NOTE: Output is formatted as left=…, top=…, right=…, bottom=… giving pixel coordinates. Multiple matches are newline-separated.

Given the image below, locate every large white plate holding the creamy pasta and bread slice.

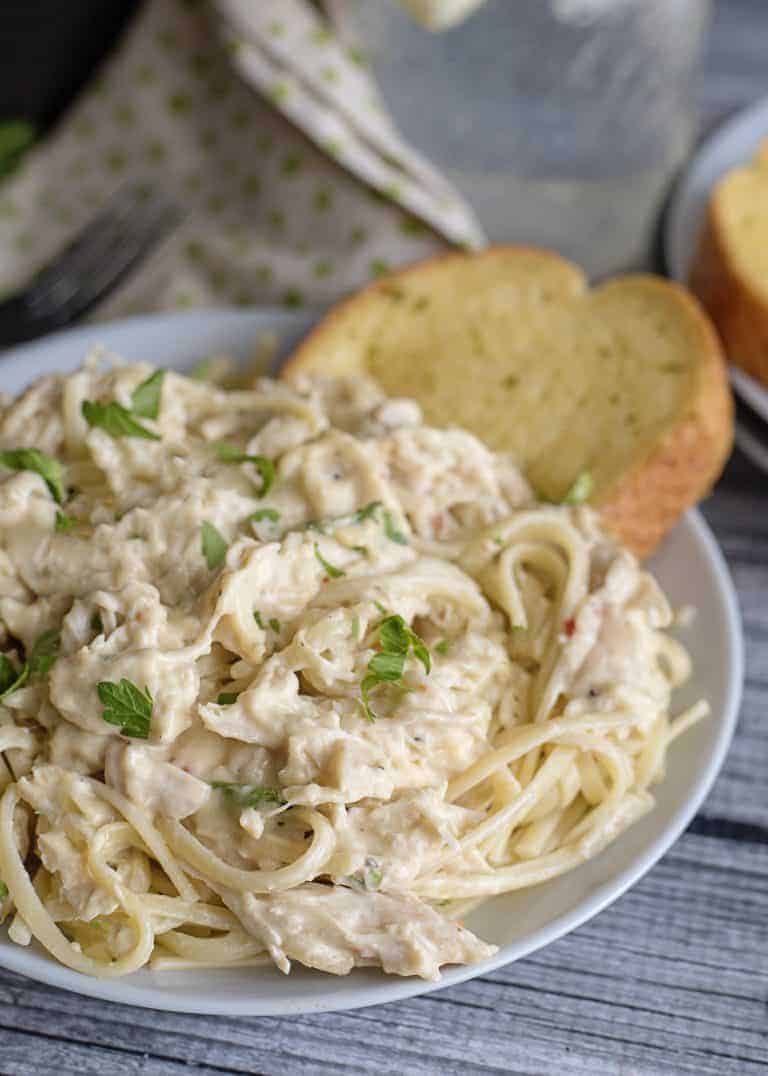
left=0, top=311, right=742, bottom=1016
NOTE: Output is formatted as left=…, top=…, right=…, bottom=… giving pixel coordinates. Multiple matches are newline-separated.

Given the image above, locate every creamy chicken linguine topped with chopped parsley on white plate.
left=0, top=355, right=707, bottom=979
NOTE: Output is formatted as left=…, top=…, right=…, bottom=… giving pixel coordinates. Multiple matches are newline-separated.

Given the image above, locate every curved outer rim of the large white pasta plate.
left=0, top=307, right=744, bottom=1017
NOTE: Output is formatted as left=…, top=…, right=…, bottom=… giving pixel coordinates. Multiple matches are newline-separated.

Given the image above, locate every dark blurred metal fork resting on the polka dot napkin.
left=0, top=187, right=180, bottom=346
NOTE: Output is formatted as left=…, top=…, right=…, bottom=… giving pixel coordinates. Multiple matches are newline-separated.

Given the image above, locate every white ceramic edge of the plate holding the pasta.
left=0, top=310, right=743, bottom=1016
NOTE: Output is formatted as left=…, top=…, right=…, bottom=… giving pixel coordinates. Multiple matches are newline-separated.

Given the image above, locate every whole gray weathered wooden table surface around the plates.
left=0, top=0, right=768, bottom=1076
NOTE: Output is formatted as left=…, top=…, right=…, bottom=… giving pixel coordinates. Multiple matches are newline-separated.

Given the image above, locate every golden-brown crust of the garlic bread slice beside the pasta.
left=282, top=246, right=733, bottom=557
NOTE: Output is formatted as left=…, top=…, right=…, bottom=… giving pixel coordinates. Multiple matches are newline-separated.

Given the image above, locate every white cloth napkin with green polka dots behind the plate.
left=0, top=0, right=483, bottom=316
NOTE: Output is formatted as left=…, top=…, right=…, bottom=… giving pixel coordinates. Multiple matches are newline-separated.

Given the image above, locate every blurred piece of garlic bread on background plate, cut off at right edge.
left=691, top=139, right=768, bottom=385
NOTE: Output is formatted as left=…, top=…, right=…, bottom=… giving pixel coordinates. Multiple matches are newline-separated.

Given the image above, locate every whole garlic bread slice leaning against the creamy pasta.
left=284, top=246, right=733, bottom=555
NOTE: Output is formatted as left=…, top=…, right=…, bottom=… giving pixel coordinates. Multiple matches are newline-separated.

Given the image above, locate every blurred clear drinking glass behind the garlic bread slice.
left=340, top=0, right=711, bottom=277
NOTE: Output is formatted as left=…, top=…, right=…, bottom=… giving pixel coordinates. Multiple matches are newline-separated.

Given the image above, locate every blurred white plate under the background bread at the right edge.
left=664, top=99, right=768, bottom=470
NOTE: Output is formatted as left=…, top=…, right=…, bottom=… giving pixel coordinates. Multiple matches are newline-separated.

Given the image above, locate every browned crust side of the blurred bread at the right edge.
left=689, top=202, right=768, bottom=385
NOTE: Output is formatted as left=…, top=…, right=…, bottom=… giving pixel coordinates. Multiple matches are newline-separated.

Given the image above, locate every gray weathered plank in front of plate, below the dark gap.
left=0, top=834, right=768, bottom=1076
